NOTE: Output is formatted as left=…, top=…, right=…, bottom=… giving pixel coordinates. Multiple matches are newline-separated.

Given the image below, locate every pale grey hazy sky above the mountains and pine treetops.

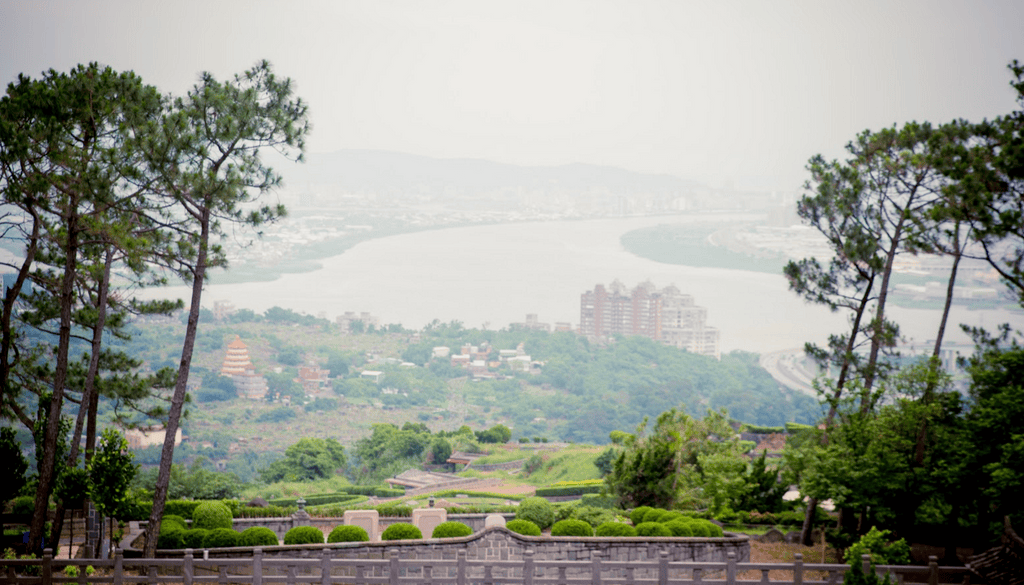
left=0, top=0, right=1024, bottom=190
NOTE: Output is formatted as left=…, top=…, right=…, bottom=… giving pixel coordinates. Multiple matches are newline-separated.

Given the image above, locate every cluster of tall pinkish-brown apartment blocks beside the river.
left=580, top=279, right=721, bottom=360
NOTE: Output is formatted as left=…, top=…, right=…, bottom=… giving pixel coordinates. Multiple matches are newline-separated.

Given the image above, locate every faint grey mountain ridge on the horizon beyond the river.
left=283, top=150, right=700, bottom=196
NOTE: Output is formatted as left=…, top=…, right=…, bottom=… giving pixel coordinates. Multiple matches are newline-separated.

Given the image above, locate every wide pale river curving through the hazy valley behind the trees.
left=147, top=214, right=1024, bottom=352
